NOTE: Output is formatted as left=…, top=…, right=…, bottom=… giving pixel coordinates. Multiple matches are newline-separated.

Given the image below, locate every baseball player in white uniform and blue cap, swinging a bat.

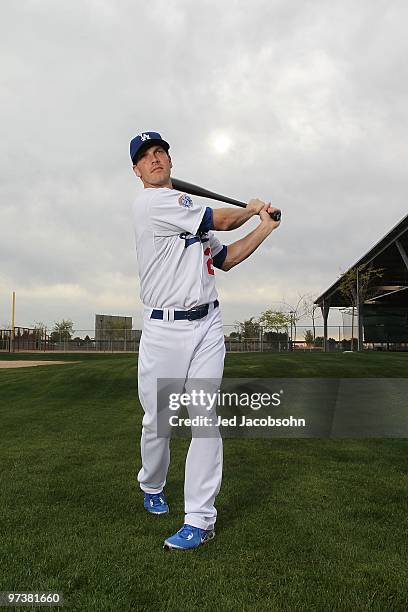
left=130, top=132, right=280, bottom=550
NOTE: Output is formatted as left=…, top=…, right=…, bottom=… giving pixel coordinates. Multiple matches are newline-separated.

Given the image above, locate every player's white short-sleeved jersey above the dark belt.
left=133, top=187, right=223, bottom=310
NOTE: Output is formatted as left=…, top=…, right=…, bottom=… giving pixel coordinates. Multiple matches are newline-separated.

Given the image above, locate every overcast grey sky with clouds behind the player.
left=0, top=0, right=408, bottom=330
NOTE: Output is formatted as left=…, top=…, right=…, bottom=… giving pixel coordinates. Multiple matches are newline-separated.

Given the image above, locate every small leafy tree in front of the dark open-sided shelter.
left=339, top=264, right=384, bottom=350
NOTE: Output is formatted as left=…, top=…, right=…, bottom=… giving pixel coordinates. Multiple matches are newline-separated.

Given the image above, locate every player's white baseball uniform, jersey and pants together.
left=133, top=188, right=226, bottom=529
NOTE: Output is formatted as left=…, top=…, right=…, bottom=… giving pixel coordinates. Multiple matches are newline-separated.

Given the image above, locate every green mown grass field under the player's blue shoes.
left=0, top=353, right=408, bottom=612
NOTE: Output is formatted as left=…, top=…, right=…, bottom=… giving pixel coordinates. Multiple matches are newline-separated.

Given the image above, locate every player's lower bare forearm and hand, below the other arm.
left=220, top=204, right=280, bottom=272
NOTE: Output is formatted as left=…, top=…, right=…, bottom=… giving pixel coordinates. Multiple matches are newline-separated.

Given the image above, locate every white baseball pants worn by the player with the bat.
left=138, top=305, right=225, bottom=529
